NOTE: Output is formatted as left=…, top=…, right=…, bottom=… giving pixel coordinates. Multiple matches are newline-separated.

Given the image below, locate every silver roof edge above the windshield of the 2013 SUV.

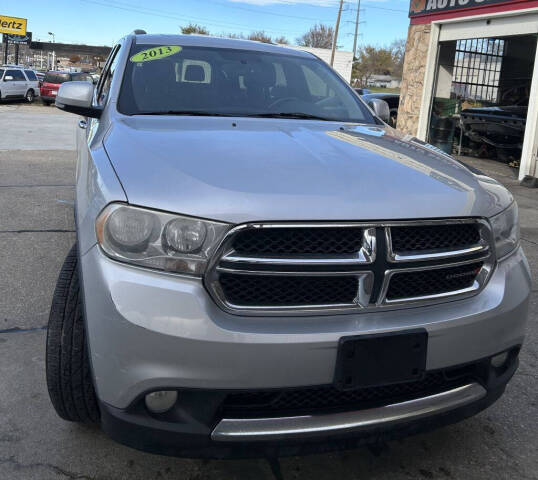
left=135, top=34, right=314, bottom=58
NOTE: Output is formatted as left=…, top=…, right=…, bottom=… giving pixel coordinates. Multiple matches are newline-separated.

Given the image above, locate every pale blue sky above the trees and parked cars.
left=0, top=0, right=409, bottom=51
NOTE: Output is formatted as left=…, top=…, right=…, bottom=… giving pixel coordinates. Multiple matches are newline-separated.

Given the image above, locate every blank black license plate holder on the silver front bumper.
left=334, top=329, right=428, bottom=390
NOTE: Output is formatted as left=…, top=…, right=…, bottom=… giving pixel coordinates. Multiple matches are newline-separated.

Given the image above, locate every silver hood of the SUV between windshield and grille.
left=104, top=116, right=511, bottom=223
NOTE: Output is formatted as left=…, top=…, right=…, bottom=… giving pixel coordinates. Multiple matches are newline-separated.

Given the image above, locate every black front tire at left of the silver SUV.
left=46, top=244, right=99, bottom=423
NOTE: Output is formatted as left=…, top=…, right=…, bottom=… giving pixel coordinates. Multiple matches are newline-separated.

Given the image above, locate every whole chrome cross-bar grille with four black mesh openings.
left=205, top=219, right=495, bottom=315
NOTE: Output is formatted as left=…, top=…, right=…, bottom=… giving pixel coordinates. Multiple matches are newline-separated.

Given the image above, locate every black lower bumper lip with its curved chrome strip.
left=100, top=368, right=510, bottom=458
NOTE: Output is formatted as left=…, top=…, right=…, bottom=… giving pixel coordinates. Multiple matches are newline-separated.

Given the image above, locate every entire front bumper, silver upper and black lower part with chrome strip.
left=81, top=246, right=531, bottom=457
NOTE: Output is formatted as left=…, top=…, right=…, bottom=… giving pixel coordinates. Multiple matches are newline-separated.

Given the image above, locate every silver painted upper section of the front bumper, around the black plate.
left=81, top=247, right=531, bottom=408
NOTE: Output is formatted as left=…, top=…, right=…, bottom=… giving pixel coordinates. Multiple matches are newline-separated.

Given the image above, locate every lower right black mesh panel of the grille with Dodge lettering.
left=387, top=262, right=482, bottom=300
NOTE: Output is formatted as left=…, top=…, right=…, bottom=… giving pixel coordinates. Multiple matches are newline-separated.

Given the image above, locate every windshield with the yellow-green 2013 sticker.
left=118, top=45, right=375, bottom=123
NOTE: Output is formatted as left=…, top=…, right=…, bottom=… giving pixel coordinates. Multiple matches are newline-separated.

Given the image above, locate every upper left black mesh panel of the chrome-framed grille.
left=233, top=227, right=363, bottom=255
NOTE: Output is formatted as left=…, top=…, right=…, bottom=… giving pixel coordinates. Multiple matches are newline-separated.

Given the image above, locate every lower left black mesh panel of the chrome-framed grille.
left=220, top=274, right=358, bottom=306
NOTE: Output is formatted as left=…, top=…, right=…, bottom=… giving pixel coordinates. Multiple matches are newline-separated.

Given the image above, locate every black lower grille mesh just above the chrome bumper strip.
left=223, top=368, right=471, bottom=414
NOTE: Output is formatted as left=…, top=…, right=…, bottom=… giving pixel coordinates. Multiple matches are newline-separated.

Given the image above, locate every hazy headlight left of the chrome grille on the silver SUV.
left=96, top=203, right=230, bottom=275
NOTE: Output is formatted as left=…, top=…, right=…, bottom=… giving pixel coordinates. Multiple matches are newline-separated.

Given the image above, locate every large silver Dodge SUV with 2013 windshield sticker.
left=47, top=33, right=531, bottom=457
